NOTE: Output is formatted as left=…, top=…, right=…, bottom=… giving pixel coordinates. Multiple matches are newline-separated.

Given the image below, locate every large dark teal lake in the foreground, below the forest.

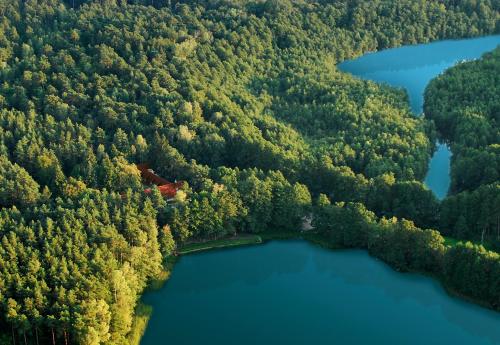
left=141, top=241, right=500, bottom=345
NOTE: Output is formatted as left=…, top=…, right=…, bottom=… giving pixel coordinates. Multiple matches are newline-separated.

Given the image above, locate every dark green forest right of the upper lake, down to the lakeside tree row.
left=425, top=47, right=500, bottom=248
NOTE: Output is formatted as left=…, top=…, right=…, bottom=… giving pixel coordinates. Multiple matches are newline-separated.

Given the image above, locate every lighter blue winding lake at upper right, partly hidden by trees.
left=338, top=35, right=500, bottom=199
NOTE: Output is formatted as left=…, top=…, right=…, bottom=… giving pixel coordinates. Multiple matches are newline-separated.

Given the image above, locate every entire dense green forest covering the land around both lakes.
left=0, top=0, right=500, bottom=345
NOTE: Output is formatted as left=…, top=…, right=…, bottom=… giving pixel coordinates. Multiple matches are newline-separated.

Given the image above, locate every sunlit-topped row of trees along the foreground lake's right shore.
left=313, top=198, right=500, bottom=309
